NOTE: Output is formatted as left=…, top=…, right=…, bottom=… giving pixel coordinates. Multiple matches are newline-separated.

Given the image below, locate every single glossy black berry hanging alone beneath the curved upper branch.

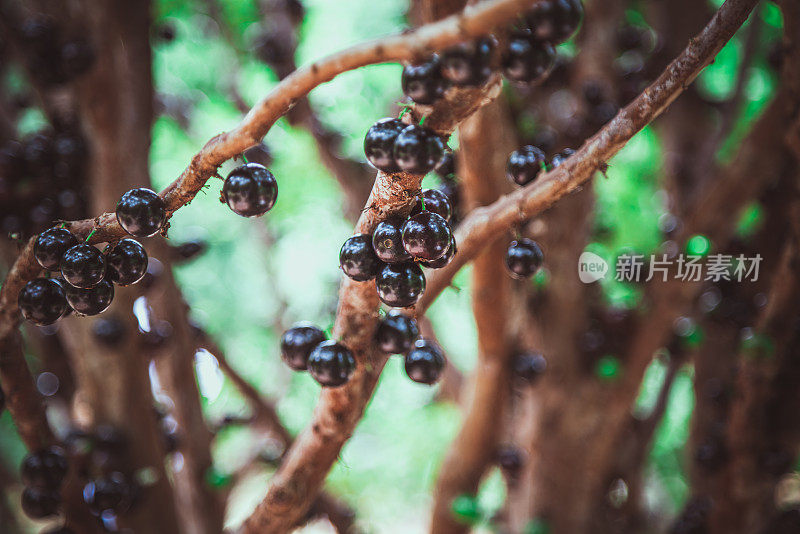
left=222, top=163, right=278, bottom=217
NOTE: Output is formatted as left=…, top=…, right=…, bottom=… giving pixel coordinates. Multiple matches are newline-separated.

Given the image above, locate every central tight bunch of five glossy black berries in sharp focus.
left=339, top=189, right=456, bottom=308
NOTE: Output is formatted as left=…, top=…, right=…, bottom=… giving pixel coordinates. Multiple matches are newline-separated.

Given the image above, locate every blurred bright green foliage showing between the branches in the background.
left=0, top=0, right=782, bottom=534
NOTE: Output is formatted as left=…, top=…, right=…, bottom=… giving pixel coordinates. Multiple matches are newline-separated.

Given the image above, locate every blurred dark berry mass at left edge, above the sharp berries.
left=0, top=125, right=87, bottom=238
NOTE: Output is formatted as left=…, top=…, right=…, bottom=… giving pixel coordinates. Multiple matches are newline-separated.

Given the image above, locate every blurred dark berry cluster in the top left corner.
left=10, top=16, right=95, bottom=86
